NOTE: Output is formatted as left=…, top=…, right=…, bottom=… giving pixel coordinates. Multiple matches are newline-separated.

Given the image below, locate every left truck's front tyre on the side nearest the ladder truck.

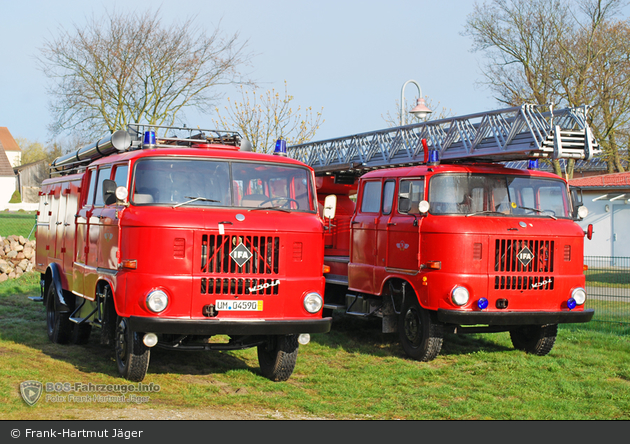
left=258, top=335, right=299, bottom=381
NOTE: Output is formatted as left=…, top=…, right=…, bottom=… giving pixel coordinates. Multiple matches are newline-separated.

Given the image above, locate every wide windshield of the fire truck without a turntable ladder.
left=131, top=159, right=315, bottom=212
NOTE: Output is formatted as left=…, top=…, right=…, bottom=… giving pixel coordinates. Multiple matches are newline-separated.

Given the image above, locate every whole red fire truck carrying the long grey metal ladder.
left=289, top=106, right=599, bottom=361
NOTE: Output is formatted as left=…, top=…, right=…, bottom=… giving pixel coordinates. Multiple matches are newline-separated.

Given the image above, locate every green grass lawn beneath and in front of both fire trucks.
left=0, top=274, right=630, bottom=420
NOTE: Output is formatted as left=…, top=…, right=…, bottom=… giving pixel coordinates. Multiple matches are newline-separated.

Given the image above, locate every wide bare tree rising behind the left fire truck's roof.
left=39, top=10, right=251, bottom=136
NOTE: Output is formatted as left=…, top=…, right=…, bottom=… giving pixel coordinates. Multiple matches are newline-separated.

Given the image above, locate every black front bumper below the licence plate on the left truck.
left=129, top=316, right=332, bottom=336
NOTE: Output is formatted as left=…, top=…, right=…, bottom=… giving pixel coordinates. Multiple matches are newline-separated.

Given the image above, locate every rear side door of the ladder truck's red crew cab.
left=348, top=179, right=382, bottom=293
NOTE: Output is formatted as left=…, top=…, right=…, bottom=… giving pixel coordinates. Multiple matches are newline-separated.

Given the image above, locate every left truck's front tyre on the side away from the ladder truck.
left=114, top=316, right=150, bottom=382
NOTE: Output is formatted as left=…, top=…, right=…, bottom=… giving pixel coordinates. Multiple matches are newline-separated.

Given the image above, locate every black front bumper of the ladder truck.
left=437, top=308, right=595, bottom=325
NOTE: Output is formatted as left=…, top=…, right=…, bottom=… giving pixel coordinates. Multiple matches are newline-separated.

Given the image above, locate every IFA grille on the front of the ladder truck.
left=494, top=239, right=555, bottom=290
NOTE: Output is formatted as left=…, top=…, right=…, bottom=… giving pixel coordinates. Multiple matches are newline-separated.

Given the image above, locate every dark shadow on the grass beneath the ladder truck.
left=313, top=312, right=513, bottom=358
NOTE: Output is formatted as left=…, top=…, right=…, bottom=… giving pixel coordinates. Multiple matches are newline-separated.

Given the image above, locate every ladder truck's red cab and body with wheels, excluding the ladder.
left=318, top=162, right=593, bottom=361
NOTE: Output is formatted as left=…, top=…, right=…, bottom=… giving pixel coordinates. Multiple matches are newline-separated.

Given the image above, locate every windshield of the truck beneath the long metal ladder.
left=429, top=174, right=570, bottom=218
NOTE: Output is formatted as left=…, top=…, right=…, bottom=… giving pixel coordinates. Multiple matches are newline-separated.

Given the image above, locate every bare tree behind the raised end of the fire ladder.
left=463, top=0, right=630, bottom=177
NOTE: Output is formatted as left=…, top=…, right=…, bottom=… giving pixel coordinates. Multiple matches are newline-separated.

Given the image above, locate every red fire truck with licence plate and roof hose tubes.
left=36, top=124, right=331, bottom=381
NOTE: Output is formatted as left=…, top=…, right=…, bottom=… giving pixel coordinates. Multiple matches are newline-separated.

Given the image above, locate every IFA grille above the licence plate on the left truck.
left=200, top=234, right=281, bottom=295
